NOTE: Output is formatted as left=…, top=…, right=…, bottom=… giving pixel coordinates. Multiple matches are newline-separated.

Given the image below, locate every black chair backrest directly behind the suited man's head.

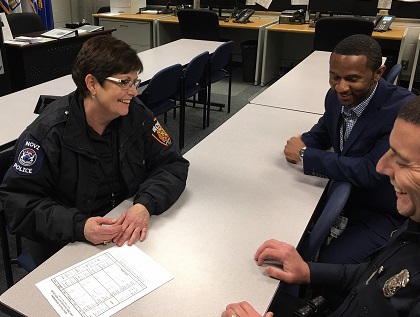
left=313, top=17, right=374, bottom=52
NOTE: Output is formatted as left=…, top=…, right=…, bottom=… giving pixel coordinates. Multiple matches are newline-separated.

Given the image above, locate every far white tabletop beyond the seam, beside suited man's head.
left=250, top=51, right=331, bottom=115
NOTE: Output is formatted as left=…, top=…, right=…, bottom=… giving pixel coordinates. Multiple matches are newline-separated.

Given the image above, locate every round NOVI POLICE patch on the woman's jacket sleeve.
left=13, top=139, right=44, bottom=175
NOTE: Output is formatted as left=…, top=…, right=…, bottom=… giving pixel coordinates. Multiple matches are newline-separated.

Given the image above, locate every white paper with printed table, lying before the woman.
left=36, top=244, right=173, bottom=317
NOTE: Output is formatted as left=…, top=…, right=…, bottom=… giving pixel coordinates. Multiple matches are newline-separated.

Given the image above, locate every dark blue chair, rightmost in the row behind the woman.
left=206, top=41, right=233, bottom=126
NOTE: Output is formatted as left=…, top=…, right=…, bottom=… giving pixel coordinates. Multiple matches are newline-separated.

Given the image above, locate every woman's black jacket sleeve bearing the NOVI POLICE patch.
left=0, top=132, right=86, bottom=244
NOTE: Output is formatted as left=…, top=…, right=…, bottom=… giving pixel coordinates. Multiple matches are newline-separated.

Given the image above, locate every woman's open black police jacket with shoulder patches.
left=0, top=91, right=189, bottom=245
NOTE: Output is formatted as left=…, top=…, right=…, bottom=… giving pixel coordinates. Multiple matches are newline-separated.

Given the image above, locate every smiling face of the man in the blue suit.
left=329, top=53, right=385, bottom=109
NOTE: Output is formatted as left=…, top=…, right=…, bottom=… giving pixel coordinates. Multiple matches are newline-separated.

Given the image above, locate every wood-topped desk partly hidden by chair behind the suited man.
left=261, top=24, right=407, bottom=86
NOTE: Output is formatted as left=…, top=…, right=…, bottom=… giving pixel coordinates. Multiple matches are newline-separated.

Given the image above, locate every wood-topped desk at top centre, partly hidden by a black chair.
left=156, top=16, right=278, bottom=85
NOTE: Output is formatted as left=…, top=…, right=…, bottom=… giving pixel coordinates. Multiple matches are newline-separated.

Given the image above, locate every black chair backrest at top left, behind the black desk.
left=7, top=12, right=45, bottom=37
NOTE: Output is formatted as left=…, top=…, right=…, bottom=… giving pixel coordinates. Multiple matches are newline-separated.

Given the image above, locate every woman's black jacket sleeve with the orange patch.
left=134, top=119, right=189, bottom=215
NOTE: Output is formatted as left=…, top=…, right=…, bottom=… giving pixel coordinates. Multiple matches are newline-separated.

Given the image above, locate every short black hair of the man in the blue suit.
left=332, top=34, right=382, bottom=72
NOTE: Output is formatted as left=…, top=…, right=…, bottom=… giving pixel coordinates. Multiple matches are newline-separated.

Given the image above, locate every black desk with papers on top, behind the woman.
left=5, top=30, right=113, bottom=94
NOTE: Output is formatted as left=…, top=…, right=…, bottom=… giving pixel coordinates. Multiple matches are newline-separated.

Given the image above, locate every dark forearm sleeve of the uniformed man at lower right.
left=308, top=262, right=368, bottom=291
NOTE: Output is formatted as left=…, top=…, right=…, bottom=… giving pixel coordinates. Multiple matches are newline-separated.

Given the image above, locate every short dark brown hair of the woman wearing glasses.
left=72, top=35, right=143, bottom=97
